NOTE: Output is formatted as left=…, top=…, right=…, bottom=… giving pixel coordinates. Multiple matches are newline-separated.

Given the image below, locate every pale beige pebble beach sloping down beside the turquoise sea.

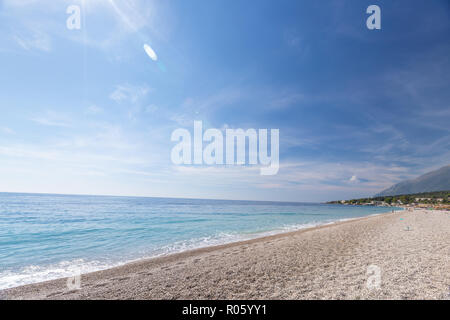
left=0, top=210, right=450, bottom=299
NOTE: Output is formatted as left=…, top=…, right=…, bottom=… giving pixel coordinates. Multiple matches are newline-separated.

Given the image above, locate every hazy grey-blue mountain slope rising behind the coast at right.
left=375, top=165, right=450, bottom=197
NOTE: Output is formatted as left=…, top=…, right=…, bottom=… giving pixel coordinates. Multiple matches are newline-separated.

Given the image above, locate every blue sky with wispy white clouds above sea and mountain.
left=0, top=0, right=450, bottom=202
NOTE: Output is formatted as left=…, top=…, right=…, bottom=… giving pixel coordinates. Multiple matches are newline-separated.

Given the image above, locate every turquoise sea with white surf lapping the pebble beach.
left=0, top=193, right=390, bottom=289
